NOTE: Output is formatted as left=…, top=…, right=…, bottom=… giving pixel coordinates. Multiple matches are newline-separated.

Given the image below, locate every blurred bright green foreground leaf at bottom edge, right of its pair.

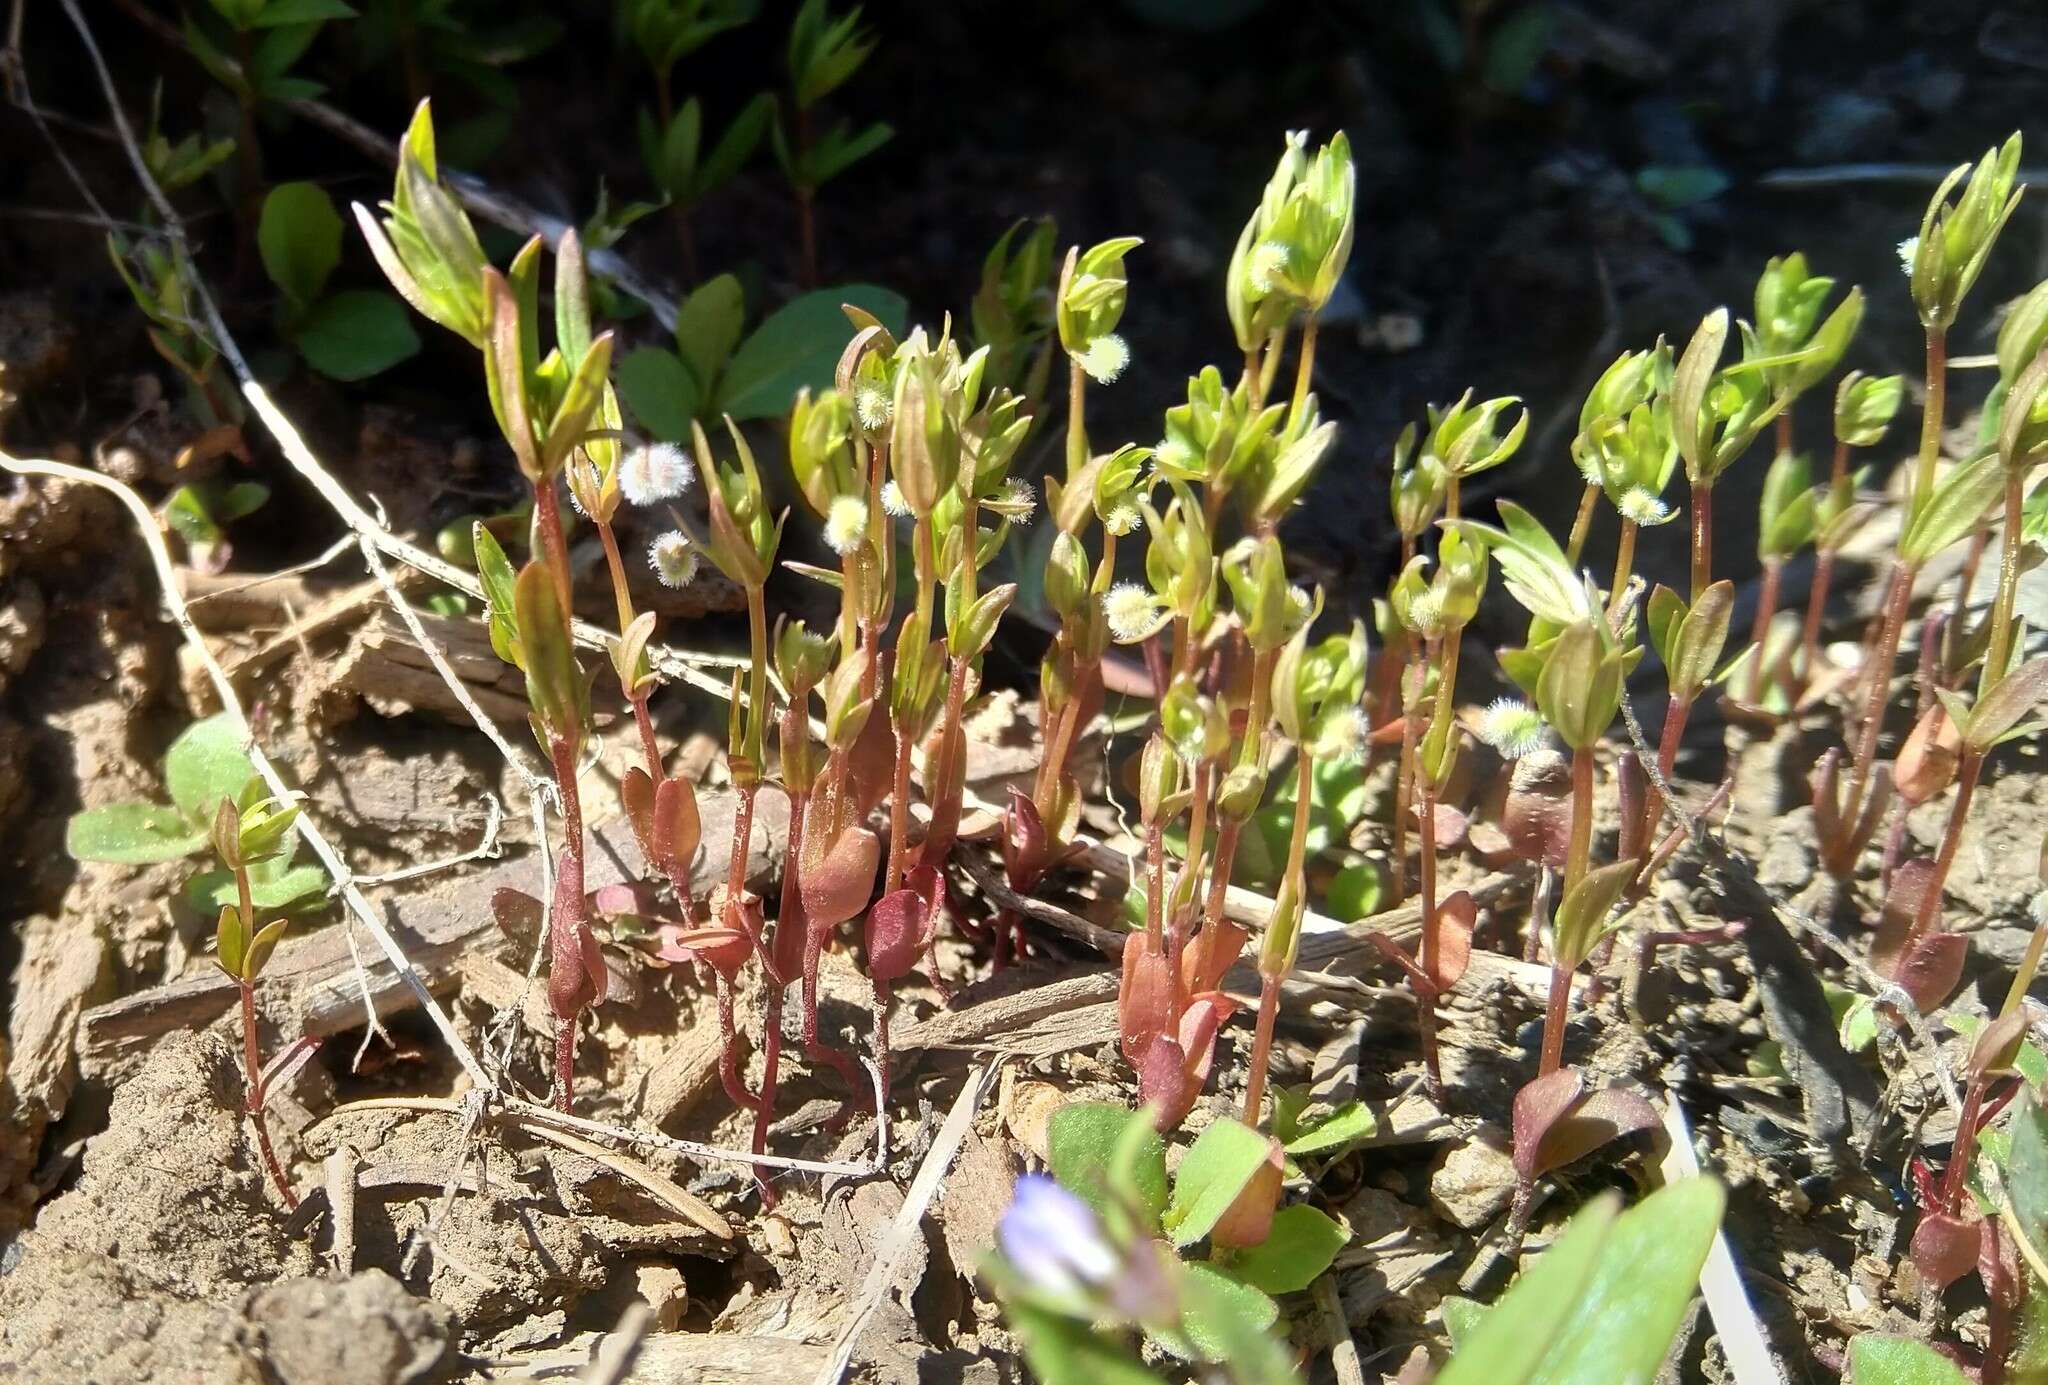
left=1523, top=1178, right=1726, bottom=1385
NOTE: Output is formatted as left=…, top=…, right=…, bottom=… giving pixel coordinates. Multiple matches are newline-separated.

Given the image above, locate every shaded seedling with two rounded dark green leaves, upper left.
left=256, top=182, right=420, bottom=381
